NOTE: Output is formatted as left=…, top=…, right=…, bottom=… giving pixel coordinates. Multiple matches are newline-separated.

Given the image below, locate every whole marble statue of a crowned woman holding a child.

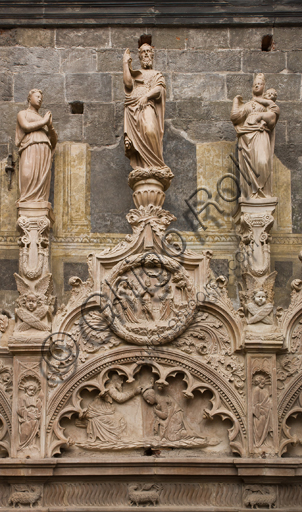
left=231, top=73, right=280, bottom=199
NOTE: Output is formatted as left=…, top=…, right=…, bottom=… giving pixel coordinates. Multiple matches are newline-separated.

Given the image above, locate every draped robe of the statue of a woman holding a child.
left=231, top=100, right=279, bottom=197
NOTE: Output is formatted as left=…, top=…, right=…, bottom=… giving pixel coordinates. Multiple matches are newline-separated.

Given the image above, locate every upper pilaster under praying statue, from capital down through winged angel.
left=10, top=201, right=54, bottom=348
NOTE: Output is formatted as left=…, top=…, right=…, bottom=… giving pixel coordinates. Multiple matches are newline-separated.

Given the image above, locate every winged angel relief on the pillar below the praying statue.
left=14, top=274, right=53, bottom=334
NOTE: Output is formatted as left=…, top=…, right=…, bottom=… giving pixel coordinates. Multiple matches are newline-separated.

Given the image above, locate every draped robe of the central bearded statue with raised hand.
left=124, top=69, right=166, bottom=169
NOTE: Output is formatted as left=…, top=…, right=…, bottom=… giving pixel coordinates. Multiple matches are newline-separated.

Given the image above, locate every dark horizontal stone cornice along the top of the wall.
left=0, top=0, right=302, bottom=27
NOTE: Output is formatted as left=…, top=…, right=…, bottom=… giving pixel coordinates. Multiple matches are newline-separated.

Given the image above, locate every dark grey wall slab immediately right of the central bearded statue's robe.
left=164, top=125, right=197, bottom=231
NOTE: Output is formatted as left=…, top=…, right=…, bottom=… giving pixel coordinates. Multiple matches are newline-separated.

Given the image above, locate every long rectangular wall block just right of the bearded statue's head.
left=167, top=50, right=241, bottom=73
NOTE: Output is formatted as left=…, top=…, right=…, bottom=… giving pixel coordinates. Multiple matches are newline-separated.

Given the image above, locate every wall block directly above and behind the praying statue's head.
left=14, top=72, right=65, bottom=106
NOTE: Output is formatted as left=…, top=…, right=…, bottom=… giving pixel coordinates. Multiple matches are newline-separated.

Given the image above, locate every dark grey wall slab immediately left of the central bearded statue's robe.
left=91, top=139, right=134, bottom=233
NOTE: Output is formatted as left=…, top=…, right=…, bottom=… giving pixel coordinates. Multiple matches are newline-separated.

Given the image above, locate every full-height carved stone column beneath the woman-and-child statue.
left=235, top=197, right=284, bottom=458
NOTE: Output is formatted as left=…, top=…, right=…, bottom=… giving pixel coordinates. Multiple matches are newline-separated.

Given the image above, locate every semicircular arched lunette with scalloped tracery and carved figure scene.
left=48, top=349, right=246, bottom=456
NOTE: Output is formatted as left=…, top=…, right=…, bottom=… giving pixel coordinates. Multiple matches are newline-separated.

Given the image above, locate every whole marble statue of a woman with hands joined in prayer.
left=15, top=89, right=57, bottom=203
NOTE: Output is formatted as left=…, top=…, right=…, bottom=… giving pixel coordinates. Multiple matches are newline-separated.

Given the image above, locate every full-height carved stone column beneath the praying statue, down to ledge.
left=9, top=201, right=54, bottom=458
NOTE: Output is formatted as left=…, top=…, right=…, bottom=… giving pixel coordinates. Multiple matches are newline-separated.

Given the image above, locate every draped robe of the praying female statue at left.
left=16, top=110, right=52, bottom=202
